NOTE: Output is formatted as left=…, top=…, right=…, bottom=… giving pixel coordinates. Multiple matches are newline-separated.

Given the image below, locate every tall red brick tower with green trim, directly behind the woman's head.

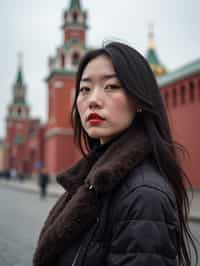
left=45, top=0, right=87, bottom=175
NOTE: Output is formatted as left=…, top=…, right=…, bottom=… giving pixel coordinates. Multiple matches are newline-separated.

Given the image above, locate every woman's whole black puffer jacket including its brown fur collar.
left=34, top=124, right=179, bottom=266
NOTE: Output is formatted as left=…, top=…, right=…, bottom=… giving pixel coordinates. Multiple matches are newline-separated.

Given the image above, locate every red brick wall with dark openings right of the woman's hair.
left=161, top=74, right=200, bottom=187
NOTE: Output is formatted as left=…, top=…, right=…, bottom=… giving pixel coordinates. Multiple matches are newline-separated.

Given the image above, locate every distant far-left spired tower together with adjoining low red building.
left=4, top=56, right=45, bottom=177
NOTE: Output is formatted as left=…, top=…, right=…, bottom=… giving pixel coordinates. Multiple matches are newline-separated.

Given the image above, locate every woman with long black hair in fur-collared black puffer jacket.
left=34, top=42, right=196, bottom=266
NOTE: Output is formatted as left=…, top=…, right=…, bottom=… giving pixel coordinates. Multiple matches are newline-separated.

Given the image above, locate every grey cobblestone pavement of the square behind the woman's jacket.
left=0, top=187, right=200, bottom=266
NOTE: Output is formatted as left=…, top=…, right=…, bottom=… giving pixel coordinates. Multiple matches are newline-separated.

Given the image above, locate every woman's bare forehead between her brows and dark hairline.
left=81, top=55, right=116, bottom=81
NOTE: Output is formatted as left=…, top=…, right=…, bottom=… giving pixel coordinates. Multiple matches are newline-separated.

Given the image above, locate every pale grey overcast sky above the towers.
left=0, top=0, right=200, bottom=137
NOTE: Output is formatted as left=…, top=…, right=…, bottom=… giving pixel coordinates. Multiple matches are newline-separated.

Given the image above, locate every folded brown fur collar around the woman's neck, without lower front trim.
left=57, top=123, right=150, bottom=194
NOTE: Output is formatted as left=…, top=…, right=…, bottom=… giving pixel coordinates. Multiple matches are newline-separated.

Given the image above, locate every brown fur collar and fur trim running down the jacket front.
left=33, top=126, right=150, bottom=266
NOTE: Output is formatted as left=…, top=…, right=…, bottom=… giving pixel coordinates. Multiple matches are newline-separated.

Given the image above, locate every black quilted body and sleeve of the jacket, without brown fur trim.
left=58, top=162, right=178, bottom=266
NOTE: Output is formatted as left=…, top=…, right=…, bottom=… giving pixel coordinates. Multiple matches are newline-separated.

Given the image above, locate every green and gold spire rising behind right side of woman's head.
left=146, top=23, right=167, bottom=76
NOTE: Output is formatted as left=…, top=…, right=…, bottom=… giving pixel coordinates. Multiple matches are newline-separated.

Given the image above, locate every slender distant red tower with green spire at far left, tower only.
left=5, top=55, right=30, bottom=172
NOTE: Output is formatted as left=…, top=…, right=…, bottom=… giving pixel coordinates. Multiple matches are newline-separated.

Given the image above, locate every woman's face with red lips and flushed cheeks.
left=77, top=55, right=136, bottom=144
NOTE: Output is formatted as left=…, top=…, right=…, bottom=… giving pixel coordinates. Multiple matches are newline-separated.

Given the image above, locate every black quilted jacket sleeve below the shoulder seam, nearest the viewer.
left=106, top=186, right=178, bottom=266
